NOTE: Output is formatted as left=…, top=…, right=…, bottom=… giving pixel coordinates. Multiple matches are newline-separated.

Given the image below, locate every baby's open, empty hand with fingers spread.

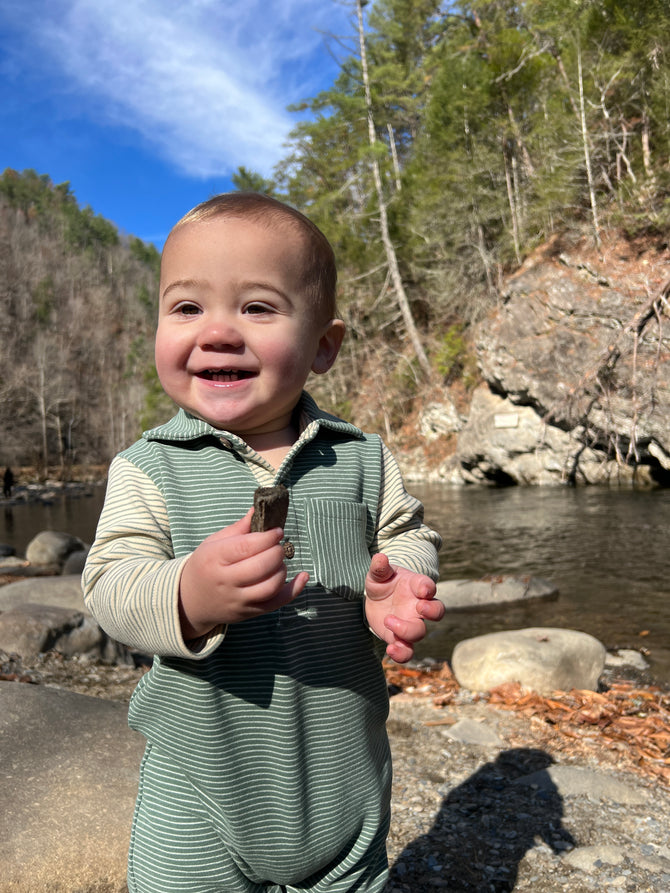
left=365, top=553, right=444, bottom=664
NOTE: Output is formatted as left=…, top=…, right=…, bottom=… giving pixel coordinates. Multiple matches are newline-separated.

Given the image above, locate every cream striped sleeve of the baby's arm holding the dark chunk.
left=82, top=456, right=223, bottom=659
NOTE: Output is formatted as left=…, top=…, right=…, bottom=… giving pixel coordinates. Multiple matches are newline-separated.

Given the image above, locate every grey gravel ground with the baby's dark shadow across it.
left=388, top=696, right=670, bottom=893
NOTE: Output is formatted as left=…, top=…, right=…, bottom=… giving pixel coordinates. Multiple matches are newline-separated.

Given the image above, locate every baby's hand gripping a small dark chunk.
left=179, top=509, right=308, bottom=640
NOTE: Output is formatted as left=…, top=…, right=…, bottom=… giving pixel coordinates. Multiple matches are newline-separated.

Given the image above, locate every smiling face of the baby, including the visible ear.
left=156, top=217, right=341, bottom=441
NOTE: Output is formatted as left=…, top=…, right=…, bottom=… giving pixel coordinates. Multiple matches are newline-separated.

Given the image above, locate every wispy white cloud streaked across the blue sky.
left=0, top=0, right=347, bottom=177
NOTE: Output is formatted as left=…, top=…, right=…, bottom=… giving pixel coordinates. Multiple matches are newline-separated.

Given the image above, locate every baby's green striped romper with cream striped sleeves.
left=84, top=395, right=436, bottom=893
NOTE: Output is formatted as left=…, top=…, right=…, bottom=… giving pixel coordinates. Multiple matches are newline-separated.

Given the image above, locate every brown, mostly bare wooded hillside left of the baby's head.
left=0, top=170, right=165, bottom=476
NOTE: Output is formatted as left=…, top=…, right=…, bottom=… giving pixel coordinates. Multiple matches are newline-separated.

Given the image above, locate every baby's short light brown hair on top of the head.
left=168, top=192, right=337, bottom=319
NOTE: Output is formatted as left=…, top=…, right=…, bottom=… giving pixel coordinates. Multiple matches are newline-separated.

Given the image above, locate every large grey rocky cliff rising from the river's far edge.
left=448, top=233, right=670, bottom=485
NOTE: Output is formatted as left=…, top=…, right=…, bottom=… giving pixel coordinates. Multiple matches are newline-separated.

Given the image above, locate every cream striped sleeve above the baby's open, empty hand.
left=375, top=444, right=442, bottom=580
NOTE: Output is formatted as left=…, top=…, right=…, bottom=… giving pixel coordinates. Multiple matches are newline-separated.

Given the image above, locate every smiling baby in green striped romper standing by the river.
left=84, top=193, right=444, bottom=893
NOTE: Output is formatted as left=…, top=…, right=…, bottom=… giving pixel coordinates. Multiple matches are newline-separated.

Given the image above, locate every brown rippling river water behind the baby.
left=0, top=484, right=670, bottom=684
